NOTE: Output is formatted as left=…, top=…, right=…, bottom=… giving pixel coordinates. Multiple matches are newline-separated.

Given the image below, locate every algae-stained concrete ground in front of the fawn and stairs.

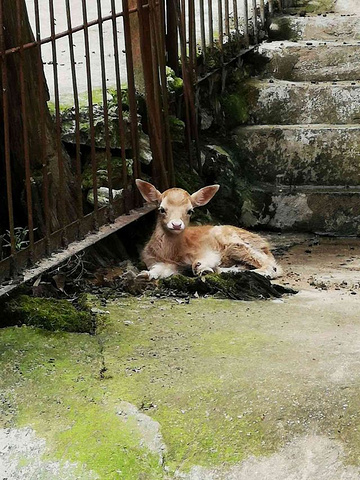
left=0, top=236, right=360, bottom=480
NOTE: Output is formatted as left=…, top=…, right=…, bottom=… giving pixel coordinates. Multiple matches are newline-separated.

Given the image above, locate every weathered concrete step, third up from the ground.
left=239, top=79, right=360, bottom=125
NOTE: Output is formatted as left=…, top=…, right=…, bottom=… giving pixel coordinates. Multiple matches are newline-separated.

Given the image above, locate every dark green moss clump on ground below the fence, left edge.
left=6, top=295, right=94, bottom=332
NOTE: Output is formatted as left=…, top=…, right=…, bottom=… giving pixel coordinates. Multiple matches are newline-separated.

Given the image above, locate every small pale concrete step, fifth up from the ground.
left=269, top=14, right=360, bottom=41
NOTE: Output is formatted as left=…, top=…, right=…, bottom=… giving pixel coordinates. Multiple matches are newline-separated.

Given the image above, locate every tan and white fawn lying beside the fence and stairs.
left=136, top=180, right=281, bottom=279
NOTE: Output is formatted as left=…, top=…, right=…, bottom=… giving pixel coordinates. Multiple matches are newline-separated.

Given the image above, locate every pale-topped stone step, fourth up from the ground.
left=252, top=41, right=360, bottom=81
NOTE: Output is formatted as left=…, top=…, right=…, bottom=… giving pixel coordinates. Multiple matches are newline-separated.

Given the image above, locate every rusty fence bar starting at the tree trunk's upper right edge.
left=34, top=0, right=51, bottom=251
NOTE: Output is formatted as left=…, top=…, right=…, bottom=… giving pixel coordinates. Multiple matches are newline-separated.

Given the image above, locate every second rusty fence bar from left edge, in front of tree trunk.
left=16, top=0, right=34, bottom=262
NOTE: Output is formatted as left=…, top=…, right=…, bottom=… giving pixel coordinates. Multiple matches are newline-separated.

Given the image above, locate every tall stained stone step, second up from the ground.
left=232, top=124, right=360, bottom=186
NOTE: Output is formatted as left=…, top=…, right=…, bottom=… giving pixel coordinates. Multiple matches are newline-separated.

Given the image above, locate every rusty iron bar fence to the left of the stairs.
left=0, top=0, right=273, bottom=285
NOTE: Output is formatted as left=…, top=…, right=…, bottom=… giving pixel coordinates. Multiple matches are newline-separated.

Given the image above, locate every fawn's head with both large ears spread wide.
left=136, top=179, right=220, bottom=235
